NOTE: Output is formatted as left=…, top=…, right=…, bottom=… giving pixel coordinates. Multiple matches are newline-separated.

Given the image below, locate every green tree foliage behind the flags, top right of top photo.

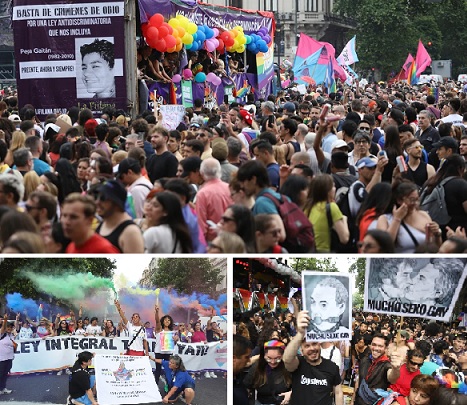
left=333, top=0, right=467, bottom=80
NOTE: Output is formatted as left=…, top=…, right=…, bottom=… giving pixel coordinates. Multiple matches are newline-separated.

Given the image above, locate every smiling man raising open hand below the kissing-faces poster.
left=355, top=333, right=402, bottom=405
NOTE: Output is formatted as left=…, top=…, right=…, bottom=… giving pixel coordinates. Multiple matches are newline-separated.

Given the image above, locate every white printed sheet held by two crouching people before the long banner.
left=94, top=355, right=162, bottom=405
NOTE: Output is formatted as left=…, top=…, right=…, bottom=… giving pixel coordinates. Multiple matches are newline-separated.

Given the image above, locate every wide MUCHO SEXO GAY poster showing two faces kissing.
left=364, top=257, right=467, bottom=321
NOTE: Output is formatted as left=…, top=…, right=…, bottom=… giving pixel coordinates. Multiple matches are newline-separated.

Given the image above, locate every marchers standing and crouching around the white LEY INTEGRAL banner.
left=0, top=300, right=227, bottom=405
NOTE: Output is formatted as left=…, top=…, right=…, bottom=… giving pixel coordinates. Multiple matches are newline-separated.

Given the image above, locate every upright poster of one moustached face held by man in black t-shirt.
left=302, top=271, right=352, bottom=342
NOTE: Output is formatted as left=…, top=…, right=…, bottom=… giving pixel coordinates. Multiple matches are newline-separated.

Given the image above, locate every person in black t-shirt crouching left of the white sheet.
left=68, top=351, right=97, bottom=405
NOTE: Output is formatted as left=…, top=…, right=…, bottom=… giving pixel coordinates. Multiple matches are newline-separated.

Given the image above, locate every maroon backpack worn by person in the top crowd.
left=264, top=193, right=315, bottom=253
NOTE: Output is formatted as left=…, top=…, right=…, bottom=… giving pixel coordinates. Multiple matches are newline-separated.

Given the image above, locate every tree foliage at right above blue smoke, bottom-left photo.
left=140, top=258, right=226, bottom=296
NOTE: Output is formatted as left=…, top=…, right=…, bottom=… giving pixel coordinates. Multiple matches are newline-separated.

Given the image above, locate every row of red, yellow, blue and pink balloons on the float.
left=142, top=13, right=271, bottom=55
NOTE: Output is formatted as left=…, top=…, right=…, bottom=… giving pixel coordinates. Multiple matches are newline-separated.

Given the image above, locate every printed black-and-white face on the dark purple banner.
left=81, top=52, right=115, bottom=98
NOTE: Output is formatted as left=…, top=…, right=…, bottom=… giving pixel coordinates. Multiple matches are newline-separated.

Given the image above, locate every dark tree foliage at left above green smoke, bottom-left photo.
left=0, top=257, right=116, bottom=307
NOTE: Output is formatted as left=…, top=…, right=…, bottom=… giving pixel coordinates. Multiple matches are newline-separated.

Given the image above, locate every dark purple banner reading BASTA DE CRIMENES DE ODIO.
left=13, top=0, right=127, bottom=117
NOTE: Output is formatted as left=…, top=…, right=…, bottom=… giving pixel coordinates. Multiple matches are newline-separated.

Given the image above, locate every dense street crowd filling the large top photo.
left=0, top=76, right=467, bottom=253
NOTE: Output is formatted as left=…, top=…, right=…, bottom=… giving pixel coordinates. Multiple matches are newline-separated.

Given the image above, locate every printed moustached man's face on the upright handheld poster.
left=310, top=284, right=345, bottom=332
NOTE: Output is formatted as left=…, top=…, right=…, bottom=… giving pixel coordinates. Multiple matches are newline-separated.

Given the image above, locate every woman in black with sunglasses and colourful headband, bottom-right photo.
left=243, top=340, right=292, bottom=405
